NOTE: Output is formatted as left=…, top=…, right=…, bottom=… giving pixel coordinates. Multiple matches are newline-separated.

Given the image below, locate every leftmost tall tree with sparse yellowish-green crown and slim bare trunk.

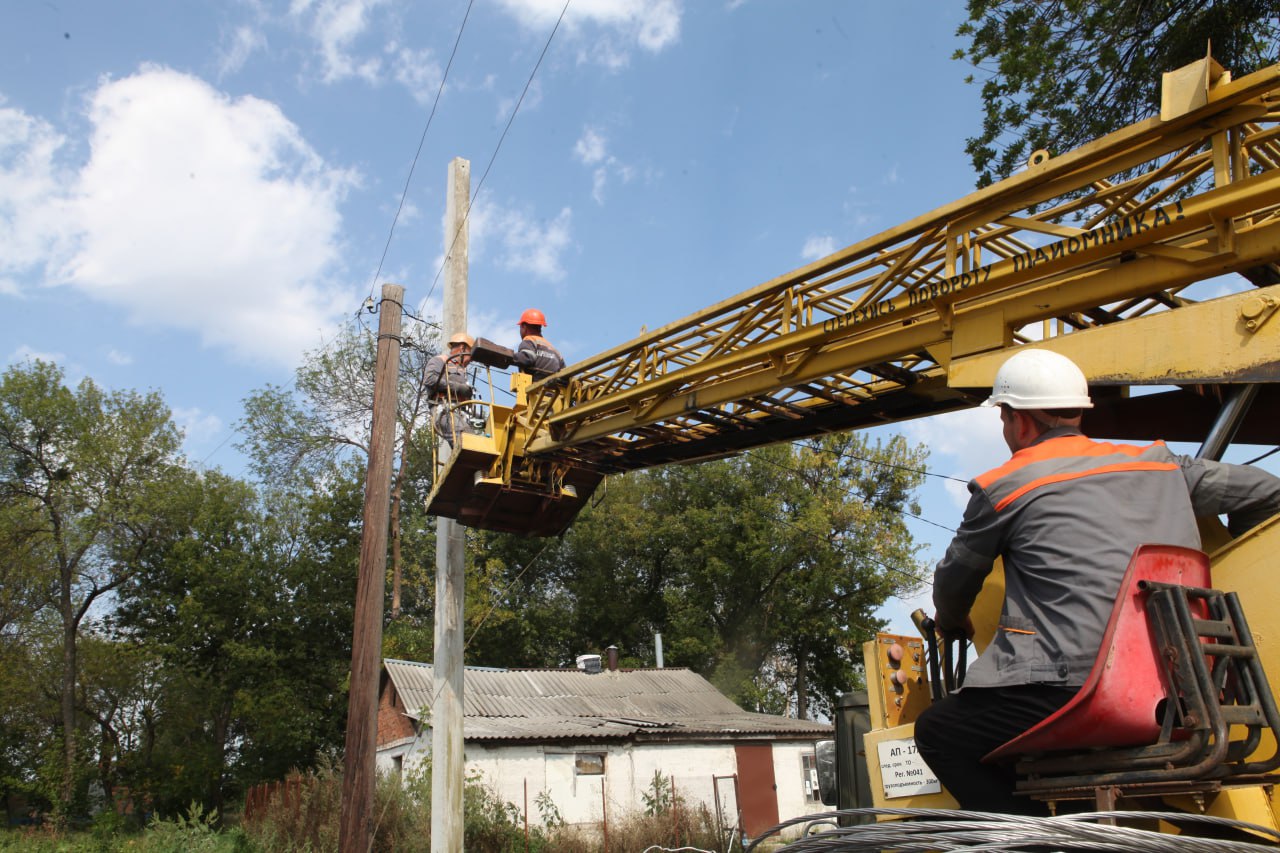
left=0, top=361, right=179, bottom=809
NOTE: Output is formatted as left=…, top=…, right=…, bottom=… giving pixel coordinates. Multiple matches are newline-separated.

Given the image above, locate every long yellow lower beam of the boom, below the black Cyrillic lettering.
left=530, top=181, right=1280, bottom=453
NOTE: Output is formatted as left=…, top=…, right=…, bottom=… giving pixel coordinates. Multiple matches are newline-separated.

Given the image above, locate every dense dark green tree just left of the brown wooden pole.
left=116, top=471, right=360, bottom=813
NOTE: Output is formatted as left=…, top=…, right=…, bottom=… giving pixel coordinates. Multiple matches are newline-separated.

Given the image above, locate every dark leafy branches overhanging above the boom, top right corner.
left=955, top=0, right=1280, bottom=187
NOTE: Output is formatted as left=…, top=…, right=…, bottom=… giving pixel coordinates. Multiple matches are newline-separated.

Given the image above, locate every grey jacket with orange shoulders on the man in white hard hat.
left=933, top=428, right=1280, bottom=686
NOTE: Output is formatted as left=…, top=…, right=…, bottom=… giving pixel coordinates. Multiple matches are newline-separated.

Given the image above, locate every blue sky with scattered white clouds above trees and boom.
left=0, top=0, right=1085, bottom=629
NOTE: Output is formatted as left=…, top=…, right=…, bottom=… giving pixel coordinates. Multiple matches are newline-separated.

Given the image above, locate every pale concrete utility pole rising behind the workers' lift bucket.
left=431, top=158, right=471, bottom=853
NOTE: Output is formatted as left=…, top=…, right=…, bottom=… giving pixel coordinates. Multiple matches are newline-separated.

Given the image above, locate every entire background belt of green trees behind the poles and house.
left=0, top=350, right=923, bottom=816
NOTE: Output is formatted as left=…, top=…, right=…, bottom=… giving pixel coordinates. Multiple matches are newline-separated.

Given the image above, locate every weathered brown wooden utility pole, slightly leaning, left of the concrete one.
left=338, top=284, right=404, bottom=853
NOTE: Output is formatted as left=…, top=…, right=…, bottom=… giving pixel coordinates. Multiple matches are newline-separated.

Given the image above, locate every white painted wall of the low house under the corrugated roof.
left=378, top=731, right=828, bottom=825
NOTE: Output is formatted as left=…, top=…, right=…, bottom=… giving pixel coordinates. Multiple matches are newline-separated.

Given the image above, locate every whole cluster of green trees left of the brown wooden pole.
left=0, top=362, right=362, bottom=816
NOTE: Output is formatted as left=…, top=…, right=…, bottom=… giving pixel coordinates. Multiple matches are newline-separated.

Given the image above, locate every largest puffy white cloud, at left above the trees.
left=0, top=67, right=356, bottom=365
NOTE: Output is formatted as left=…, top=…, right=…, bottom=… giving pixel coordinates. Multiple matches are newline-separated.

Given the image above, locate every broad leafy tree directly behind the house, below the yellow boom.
left=544, top=433, right=924, bottom=717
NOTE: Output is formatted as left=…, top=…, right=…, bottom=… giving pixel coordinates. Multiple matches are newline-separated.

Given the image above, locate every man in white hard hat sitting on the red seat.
left=915, top=350, right=1280, bottom=815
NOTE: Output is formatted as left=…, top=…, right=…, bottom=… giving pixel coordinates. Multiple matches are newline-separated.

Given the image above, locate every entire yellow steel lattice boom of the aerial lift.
left=512, top=67, right=1280, bottom=467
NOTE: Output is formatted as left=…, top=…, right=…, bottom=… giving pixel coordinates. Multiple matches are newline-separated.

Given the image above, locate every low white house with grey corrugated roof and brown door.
left=378, top=656, right=832, bottom=835
